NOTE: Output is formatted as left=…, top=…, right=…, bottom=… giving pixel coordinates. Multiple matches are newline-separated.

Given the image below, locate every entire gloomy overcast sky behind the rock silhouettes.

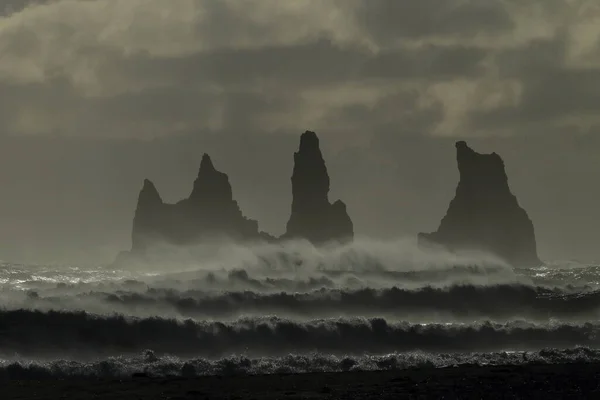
left=0, top=0, right=600, bottom=263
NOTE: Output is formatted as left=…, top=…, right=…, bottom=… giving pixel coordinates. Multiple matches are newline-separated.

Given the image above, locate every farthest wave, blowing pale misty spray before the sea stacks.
left=0, top=239, right=515, bottom=291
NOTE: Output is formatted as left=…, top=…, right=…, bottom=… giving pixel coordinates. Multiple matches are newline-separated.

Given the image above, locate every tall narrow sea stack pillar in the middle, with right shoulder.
left=282, top=131, right=354, bottom=245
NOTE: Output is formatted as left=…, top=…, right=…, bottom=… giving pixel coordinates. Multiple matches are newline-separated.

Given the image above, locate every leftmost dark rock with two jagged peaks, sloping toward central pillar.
left=132, top=154, right=266, bottom=252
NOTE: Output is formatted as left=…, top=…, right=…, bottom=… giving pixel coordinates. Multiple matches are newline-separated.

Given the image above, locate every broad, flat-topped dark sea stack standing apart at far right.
left=419, top=141, right=542, bottom=267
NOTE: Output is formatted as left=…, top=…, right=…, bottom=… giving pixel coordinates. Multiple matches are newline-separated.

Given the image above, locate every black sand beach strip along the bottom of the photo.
left=0, top=364, right=600, bottom=400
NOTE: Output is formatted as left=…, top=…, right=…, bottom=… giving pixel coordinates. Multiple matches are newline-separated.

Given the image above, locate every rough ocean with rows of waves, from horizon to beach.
left=0, top=239, right=600, bottom=378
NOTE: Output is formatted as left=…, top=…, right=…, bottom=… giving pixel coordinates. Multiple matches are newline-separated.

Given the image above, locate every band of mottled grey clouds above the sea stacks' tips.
left=0, top=0, right=600, bottom=138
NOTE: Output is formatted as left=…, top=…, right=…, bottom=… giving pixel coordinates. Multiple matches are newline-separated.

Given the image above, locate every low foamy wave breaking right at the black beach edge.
left=0, top=347, right=600, bottom=380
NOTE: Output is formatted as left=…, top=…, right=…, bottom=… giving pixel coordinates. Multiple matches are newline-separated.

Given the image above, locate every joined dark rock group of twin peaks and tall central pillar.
left=117, top=131, right=354, bottom=262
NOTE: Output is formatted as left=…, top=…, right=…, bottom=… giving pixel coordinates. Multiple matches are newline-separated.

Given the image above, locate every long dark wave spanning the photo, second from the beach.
left=0, top=310, right=600, bottom=357
